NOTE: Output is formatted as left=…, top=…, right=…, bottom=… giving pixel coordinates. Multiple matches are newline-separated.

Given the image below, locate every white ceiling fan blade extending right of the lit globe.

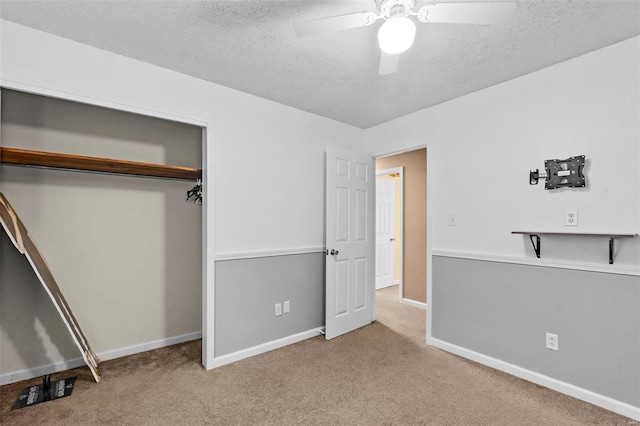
left=418, top=2, right=517, bottom=25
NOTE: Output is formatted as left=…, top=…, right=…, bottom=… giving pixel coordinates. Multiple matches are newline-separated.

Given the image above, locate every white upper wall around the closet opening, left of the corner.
left=0, top=21, right=361, bottom=380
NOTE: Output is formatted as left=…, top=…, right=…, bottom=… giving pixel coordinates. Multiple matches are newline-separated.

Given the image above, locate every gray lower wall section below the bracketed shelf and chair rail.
left=431, top=256, right=640, bottom=407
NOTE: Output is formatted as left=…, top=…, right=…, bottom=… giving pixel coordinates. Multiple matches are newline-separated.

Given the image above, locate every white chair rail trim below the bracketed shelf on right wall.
left=432, top=249, right=640, bottom=276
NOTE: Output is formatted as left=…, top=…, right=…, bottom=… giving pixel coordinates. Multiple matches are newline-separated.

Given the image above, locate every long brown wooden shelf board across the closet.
left=0, top=147, right=202, bottom=180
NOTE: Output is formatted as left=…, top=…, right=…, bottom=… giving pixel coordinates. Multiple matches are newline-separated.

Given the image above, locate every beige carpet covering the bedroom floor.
left=0, top=287, right=638, bottom=426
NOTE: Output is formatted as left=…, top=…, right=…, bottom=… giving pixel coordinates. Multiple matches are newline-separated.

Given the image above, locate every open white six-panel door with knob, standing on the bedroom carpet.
left=325, top=148, right=375, bottom=339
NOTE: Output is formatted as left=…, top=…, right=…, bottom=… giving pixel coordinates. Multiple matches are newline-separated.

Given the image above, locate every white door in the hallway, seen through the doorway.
left=376, top=177, right=396, bottom=290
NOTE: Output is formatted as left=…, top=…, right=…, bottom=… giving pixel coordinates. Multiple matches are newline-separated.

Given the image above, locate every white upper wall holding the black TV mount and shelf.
left=363, top=37, right=640, bottom=271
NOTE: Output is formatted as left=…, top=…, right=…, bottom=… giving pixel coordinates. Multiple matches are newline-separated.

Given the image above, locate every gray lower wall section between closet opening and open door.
left=215, top=253, right=325, bottom=356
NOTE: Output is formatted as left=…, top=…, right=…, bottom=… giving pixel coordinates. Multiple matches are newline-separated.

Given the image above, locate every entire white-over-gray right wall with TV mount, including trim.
left=365, top=37, right=640, bottom=419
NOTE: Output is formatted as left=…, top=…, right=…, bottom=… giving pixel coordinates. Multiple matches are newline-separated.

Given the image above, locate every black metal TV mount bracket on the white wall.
left=529, top=155, right=586, bottom=189
